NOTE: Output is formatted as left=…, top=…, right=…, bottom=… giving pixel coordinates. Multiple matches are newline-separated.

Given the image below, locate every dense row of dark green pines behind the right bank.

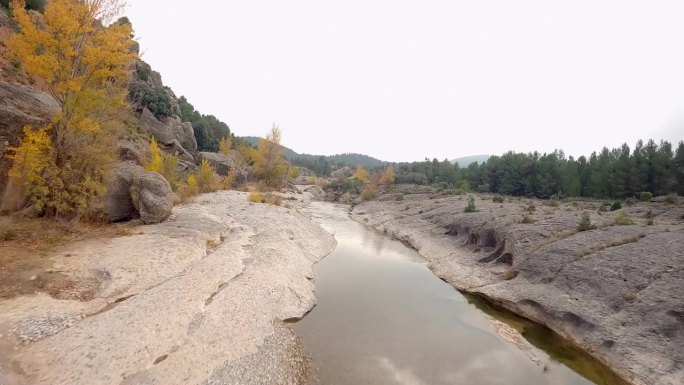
left=394, top=140, right=684, bottom=200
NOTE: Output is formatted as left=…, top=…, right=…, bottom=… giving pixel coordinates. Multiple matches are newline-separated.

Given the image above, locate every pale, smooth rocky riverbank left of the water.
left=0, top=192, right=335, bottom=385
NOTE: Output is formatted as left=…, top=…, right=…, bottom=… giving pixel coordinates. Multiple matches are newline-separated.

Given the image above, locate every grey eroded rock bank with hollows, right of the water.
left=352, top=188, right=684, bottom=385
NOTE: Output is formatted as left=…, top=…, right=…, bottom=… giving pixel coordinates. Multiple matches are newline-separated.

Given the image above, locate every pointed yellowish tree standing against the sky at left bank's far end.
left=254, top=124, right=287, bottom=187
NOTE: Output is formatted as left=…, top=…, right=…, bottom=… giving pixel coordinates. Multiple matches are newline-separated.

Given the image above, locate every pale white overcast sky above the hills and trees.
left=127, top=0, right=684, bottom=161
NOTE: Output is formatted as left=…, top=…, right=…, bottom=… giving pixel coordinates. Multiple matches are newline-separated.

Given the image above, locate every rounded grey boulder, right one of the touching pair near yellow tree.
left=129, top=171, right=173, bottom=225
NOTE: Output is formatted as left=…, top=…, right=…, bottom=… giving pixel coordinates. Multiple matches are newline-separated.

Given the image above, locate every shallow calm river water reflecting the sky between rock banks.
left=293, top=203, right=619, bottom=385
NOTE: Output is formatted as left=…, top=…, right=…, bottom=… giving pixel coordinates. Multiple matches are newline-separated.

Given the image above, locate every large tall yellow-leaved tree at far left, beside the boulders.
left=6, top=0, right=137, bottom=216
